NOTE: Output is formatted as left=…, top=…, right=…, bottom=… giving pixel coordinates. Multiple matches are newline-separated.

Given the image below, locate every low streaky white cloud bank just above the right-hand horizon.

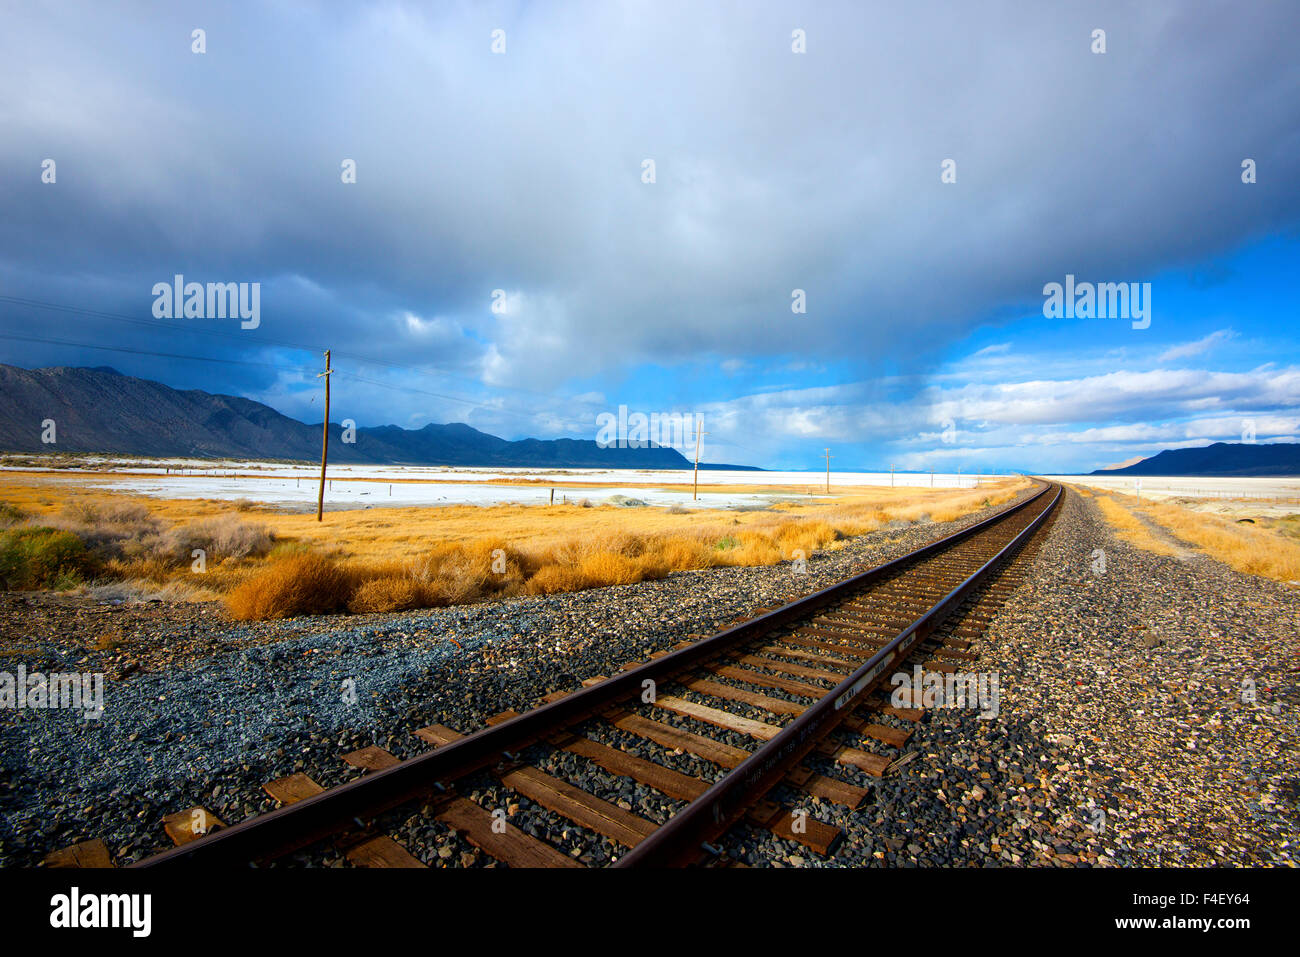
left=681, top=363, right=1300, bottom=469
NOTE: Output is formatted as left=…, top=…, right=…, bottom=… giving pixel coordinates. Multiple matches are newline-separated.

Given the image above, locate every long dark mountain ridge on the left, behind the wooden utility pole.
left=0, top=364, right=749, bottom=468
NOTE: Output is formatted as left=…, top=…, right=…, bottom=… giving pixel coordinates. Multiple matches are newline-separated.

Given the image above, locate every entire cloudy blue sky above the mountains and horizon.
left=0, top=0, right=1300, bottom=473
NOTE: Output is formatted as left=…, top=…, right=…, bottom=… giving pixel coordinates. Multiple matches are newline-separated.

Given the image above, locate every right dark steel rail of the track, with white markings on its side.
left=615, top=486, right=1061, bottom=867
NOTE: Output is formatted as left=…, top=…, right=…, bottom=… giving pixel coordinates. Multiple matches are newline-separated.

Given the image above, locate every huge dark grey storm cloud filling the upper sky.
left=0, top=0, right=1300, bottom=416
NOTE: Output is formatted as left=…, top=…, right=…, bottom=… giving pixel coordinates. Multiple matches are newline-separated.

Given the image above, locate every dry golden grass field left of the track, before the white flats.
left=0, top=473, right=1027, bottom=619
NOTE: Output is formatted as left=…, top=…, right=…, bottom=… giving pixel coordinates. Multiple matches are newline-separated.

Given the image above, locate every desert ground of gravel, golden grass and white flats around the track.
left=0, top=463, right=1300, bottom=866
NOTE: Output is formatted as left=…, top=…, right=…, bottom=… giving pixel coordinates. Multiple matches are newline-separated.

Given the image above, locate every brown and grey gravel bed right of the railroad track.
left=754, top=492, right=1300, bottom=867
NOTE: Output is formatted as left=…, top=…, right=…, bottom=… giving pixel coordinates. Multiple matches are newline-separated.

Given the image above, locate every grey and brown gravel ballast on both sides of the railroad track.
left=0, top=494, right=1297, bottom=866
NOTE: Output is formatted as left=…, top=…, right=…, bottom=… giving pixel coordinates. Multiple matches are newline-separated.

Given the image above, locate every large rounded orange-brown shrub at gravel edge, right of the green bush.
left=226, top=554, right=355, bottom=620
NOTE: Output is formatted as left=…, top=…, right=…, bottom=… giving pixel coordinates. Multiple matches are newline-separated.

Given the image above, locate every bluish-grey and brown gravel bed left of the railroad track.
left=0, top=493, right=1027, bottom=866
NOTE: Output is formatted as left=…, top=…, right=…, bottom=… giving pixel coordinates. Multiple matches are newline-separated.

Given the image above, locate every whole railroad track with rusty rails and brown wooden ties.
left=89, top=484, right=1061, bottom=867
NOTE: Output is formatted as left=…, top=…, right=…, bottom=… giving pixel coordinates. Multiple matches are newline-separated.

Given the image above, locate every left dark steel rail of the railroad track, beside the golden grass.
left=131, top=484, right=1052, bottom=867
